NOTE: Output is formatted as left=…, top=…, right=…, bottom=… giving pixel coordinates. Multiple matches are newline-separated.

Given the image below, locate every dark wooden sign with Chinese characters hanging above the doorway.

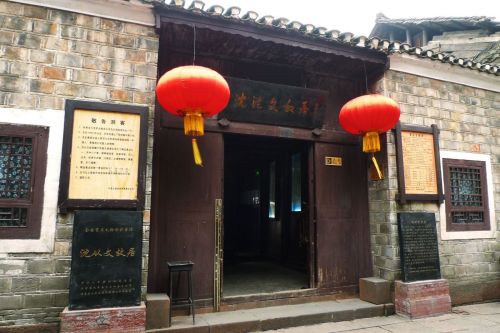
left=219, top=77, right=328, bottom=128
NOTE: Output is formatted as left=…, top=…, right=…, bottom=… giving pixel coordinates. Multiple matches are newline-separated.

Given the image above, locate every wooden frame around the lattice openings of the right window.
left=442, top=158, right=491, bottom=232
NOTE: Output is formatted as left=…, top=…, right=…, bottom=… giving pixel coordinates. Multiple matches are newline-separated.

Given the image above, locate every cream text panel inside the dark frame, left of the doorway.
left=68, top=110, right=141, bottom=200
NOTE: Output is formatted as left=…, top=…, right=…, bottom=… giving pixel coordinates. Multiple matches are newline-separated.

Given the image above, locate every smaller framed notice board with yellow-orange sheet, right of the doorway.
left=395, top=123, right=444, bottom=204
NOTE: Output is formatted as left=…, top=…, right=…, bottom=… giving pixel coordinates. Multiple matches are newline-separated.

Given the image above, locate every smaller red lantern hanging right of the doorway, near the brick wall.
left=339, top=94, right=400, bottom=179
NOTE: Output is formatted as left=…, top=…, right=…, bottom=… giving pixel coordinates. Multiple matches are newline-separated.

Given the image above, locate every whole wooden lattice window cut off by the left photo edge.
left=0, top=124, right=49, bottom=239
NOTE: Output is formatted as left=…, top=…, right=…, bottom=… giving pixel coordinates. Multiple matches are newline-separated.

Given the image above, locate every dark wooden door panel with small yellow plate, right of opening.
left=314, top=143, right=371, bottom=288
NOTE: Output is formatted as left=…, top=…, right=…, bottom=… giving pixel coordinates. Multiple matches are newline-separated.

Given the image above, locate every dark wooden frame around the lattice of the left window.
left=0, top=123, right=49, bottom=239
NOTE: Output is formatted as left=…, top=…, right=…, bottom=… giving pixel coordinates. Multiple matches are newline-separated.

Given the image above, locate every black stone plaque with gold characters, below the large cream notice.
left=69, top=210, right=142, bottom=310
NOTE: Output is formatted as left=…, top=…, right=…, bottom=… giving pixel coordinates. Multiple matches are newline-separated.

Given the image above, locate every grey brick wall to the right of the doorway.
left=369, top=69, right=500, bottom=304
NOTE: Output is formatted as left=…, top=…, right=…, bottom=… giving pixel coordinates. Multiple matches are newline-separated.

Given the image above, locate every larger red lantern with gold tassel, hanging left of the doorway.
left=156, top=66, right=230, bottom=165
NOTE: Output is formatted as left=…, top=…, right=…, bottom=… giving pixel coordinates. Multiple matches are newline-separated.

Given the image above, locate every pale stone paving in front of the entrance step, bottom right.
left=258, top=302, right=500, bottom=333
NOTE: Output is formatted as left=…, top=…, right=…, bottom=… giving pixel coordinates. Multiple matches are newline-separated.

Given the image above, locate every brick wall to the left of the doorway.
left=0, top=1, right=158, bottom=330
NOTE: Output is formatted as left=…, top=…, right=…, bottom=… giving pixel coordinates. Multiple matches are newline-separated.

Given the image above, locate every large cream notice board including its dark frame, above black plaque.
left=59, top=100, right=148, bottom=211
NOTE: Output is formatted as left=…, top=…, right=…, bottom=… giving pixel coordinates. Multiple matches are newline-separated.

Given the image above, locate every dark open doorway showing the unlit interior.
left=222, top=135, right=309, bottom=297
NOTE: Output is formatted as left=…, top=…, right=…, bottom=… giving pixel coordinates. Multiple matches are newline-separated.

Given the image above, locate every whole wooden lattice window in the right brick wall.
left=443, top=159, right=490, bottom=231
